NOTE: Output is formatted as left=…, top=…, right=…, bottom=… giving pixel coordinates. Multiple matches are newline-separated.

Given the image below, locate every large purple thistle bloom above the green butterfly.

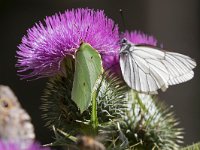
left=16, top=9, right=119, bottom=78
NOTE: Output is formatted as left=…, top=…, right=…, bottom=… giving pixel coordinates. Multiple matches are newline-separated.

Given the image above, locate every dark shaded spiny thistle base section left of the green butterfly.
left=41, top=59, right=89, bottom=134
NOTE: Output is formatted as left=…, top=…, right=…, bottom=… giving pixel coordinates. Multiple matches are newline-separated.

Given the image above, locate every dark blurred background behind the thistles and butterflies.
left=0, top=0, right=200, bottom=144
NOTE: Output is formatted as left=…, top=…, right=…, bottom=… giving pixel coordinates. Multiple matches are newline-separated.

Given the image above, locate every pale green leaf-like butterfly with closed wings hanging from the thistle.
left=72, top=43, right=103, bottom=112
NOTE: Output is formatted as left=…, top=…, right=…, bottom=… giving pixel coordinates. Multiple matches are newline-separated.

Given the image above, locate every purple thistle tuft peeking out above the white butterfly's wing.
left=122, top=31, right=157, bottom=46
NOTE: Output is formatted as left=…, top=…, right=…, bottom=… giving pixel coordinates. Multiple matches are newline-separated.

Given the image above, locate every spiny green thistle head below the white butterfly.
left=100, top=91, right=183, bottom=150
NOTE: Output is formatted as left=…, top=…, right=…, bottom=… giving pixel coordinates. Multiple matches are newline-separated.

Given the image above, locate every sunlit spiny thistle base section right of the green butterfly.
left=96, top=71, right=128, bottom=124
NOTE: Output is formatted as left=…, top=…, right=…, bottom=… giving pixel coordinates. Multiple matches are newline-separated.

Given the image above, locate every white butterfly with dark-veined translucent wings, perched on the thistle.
left=120, top=38, right=196, bottom=94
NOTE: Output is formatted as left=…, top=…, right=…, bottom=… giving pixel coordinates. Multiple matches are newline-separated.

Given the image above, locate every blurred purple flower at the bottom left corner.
left=0, top=140, right=50, bottom=150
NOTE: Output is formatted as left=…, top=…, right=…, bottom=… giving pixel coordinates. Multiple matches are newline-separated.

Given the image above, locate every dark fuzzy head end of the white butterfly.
left=119, top=38, right=133, bottom=54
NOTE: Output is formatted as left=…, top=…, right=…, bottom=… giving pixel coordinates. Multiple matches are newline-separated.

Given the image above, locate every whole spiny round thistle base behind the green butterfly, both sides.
left=41, top=66, right=127, bottom=139
